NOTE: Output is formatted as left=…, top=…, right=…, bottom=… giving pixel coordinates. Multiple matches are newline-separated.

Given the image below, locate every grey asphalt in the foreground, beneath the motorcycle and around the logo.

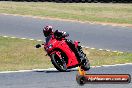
left=0, top=64, right=132, bottom=88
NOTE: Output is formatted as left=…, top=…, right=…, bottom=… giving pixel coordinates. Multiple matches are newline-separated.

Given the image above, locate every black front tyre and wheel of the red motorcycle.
left=51, top=53, right=67, bottom=72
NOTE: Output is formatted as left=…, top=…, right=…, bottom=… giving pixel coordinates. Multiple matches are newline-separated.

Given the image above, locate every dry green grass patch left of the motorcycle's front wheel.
left=0, top=37, right=52, bottom=71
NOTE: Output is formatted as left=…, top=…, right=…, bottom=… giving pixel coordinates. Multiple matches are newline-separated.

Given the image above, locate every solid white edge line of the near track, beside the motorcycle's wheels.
left=0, top=63, right=132, bottom=73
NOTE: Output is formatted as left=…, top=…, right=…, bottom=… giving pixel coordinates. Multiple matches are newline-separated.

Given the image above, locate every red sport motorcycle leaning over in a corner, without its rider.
left=36, top=35, right=90, bottom=72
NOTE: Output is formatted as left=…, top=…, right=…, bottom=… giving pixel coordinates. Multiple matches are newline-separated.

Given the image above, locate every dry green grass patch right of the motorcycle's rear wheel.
left=84, top=49, right=132, bottom=66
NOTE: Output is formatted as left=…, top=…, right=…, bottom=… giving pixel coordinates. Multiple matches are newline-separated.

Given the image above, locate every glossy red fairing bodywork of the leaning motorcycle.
left=44, top=35, right=79, bottom=68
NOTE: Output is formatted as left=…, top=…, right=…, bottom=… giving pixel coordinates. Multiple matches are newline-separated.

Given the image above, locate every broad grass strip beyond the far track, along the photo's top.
left=0, top=2, right=132, bottom=24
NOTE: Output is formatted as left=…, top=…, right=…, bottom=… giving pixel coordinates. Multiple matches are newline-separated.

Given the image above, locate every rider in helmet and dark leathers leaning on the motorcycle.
left=43, top=25, right=83, bottom=62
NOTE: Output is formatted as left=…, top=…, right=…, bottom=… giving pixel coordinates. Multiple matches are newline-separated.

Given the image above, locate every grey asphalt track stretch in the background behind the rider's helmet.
left=0, top=14, right=132, bottom=52
